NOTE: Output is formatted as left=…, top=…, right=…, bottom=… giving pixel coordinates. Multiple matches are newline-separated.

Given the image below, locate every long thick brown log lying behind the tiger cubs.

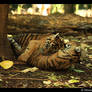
left=6, top=14, right=92, bottom=34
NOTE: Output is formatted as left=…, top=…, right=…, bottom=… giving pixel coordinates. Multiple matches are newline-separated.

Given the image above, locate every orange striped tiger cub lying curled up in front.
left=18, top=33, right=80, bottom=70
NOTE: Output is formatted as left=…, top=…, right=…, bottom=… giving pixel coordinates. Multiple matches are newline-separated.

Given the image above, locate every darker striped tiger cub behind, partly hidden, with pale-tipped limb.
left=7, top=33, right=50, bottom=57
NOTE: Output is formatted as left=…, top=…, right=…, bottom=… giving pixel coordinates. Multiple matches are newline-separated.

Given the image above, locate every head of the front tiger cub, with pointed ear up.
left=42, top=33, right=64, bottom=54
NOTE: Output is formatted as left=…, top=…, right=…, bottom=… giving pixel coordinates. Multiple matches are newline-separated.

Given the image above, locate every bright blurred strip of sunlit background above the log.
left=9, top=4, right=92, bottom=17
